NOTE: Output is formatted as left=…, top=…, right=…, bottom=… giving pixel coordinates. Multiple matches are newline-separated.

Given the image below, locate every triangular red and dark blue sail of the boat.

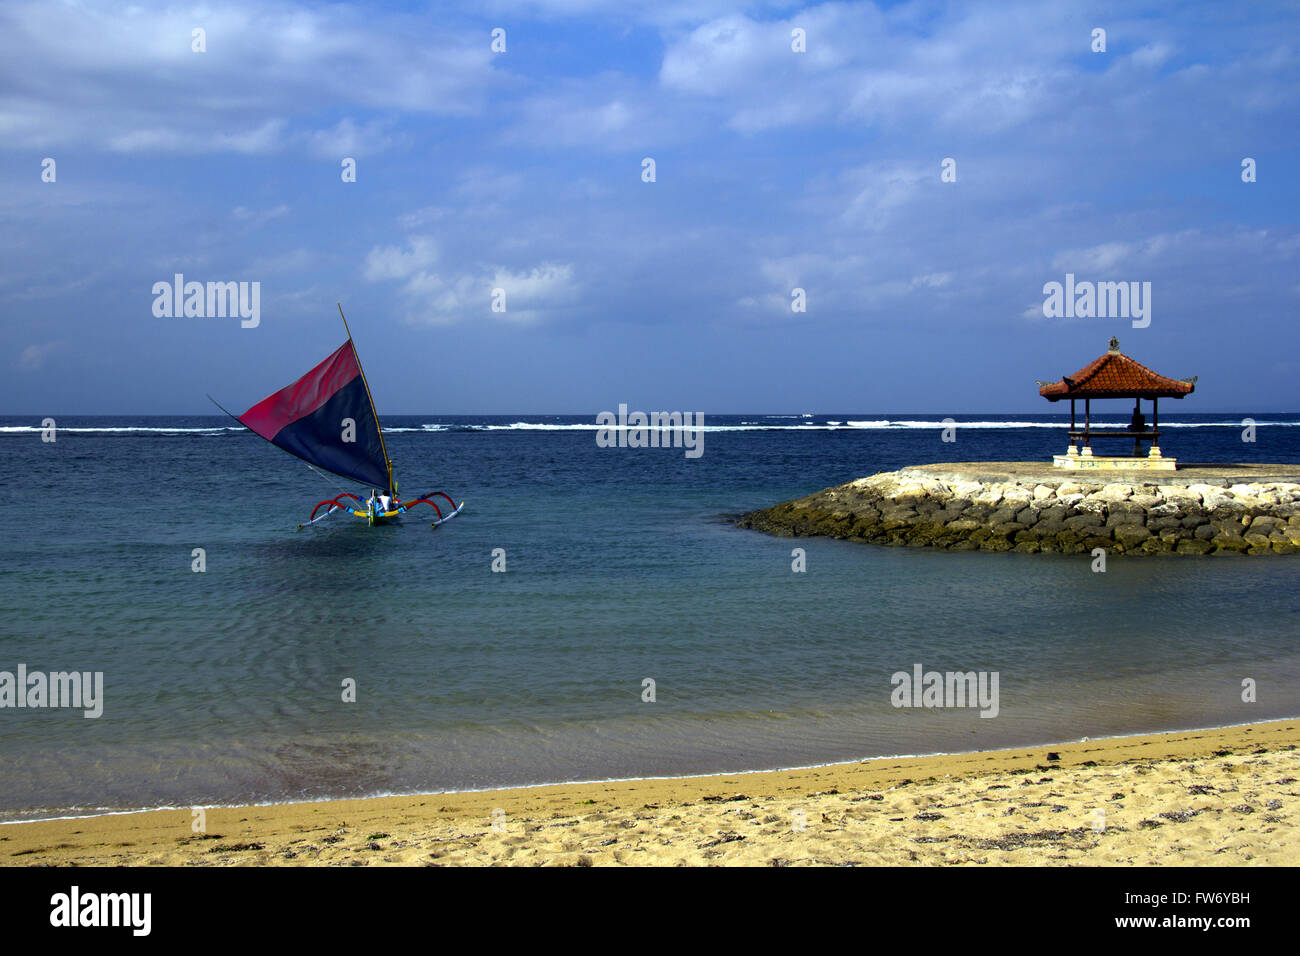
left=235, top=338, right=393, bottom=493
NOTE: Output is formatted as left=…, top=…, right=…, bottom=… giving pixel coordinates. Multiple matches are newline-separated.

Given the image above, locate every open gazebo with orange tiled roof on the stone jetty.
left=1039, top=337, right=1196, bottom=471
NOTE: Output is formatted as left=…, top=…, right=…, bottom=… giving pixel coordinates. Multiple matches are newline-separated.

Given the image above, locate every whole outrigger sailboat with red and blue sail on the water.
left=208, top=306, right=465, bottom=531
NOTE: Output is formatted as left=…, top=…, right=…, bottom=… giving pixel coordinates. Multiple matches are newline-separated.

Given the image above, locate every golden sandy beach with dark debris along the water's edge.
left=0, top=721, right=1300, bottom=866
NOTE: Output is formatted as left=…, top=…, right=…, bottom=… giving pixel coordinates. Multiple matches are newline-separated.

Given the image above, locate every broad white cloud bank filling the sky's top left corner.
left=0, top=0, right=501, bottom=155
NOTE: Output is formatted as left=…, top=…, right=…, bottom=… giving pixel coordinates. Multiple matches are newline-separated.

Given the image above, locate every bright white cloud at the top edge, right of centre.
left=659, top=4, right=1086, bottom=134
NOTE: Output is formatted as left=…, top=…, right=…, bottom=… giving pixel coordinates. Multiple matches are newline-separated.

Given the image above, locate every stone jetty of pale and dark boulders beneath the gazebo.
left=736, top=462, right=1300, bottom=554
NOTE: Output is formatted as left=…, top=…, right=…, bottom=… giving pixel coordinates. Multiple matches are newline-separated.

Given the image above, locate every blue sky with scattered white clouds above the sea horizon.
left=0, top=0, right=1300, bottom=416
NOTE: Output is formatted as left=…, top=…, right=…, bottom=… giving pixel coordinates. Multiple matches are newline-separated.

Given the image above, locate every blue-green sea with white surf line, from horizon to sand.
left=0, top=412, right=1300, bottom=819
